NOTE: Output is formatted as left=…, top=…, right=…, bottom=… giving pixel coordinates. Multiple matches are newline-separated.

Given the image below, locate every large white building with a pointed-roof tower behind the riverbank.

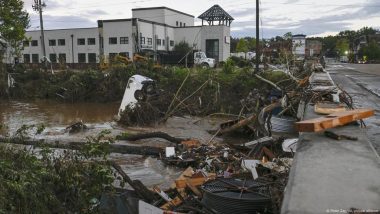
left=4, top=5, right=233, bottom=63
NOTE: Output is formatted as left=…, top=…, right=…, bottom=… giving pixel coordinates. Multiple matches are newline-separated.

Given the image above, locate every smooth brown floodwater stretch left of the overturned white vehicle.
left=0, top=100, right=119, bottom=134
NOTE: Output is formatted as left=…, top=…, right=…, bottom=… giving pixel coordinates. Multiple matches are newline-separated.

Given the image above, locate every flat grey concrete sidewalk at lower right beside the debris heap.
left=282, top=73, right=380, bottom=214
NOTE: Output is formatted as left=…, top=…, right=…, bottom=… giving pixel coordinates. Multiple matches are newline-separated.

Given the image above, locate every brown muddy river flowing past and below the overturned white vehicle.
left=0, top=100, right=221, bottom=187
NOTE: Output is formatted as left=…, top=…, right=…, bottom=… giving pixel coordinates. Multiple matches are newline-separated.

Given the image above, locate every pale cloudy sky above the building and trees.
left=24, top=0, right=380, bottom=38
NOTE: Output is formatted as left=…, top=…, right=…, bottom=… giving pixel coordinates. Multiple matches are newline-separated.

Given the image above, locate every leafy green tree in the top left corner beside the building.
left=0, top=0, right=29, bottom=58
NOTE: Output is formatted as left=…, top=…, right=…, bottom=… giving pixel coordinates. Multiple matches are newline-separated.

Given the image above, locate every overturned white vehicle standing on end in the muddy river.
left=118, top=75, right=158, bottom=119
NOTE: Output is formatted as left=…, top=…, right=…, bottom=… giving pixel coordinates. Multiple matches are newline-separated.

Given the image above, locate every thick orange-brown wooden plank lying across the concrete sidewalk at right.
left=296, top=109, right=375, bottom=132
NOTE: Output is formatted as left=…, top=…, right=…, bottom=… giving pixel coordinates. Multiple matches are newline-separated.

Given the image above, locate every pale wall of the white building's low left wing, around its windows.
left=20, top=28, right=99, bottom=63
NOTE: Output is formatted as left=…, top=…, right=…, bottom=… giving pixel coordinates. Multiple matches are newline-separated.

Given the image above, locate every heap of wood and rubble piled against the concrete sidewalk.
left=98, top=60, right=373, bottom=213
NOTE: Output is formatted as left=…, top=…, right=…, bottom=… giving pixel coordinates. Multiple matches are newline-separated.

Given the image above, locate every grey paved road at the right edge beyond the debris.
left=326, top=64, right=380, bottom=153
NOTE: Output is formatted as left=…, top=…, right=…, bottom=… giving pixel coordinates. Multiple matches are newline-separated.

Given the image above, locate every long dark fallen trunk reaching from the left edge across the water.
left=0, top=137, right=163, bottom=156
